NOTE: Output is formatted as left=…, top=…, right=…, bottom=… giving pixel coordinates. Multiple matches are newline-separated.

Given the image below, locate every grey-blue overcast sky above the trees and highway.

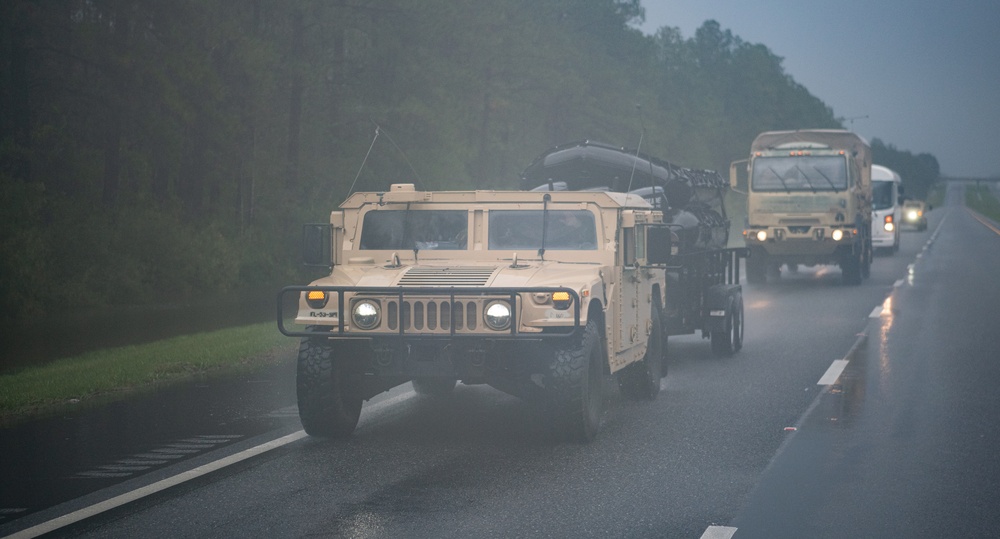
left=641, top=0, right=1000, bottom=177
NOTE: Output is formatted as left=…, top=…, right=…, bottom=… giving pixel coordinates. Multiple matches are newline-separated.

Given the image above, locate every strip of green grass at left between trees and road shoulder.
left=0, top=322, right=298, bottom=423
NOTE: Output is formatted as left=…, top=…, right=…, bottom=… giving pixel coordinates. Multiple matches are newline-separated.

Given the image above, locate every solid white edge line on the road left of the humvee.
left=8, top=430, right=306, bottom=539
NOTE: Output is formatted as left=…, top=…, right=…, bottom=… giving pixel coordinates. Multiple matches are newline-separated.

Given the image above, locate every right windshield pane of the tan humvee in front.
left=489, top=210, right=597, bottom=251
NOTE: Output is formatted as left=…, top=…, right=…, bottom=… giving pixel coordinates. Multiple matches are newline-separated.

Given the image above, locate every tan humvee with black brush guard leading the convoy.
left=278, top=184, right=673, bottom=440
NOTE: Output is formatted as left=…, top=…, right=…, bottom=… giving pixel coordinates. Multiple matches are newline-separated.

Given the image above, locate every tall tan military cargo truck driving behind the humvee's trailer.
left=730, top=129, right=872, bottom=285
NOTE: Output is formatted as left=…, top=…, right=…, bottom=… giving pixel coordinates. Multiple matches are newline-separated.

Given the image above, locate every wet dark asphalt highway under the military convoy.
left=0, top=182, right=1000, bottom=539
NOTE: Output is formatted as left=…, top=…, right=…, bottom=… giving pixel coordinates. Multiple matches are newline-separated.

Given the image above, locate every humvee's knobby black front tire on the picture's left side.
left=296, top=330, right=364, bottom=438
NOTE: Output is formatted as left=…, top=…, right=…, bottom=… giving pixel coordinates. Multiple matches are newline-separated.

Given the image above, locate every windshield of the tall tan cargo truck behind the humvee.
left=750, top=155, right=848, bottom=192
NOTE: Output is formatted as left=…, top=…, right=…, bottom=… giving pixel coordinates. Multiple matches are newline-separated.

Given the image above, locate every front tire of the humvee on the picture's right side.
left=546, top=317, right=604, bottom=442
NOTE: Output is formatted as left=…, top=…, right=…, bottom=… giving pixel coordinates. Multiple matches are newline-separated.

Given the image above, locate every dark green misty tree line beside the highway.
left=0, top=0, right=938, bottom=322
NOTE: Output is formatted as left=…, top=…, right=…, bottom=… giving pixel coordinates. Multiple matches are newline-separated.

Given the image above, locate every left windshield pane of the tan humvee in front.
left=360, top=210, right=469, bottom=250
